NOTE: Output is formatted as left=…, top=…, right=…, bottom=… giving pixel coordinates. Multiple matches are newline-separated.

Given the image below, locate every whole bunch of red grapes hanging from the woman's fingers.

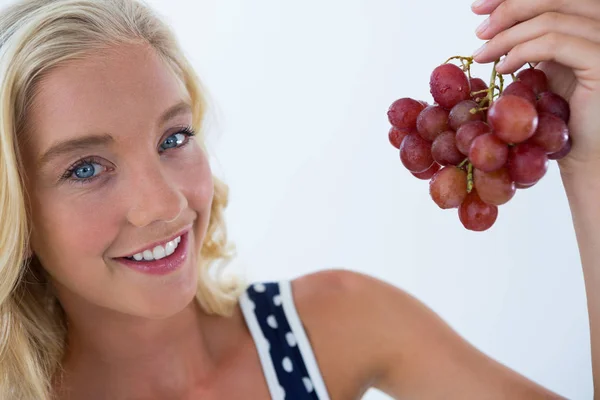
left=388, top=57, right=571, bottom=231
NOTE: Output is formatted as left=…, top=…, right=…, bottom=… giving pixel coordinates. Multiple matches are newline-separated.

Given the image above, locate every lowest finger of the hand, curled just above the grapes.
left=496, top=32, right=600, bottom=77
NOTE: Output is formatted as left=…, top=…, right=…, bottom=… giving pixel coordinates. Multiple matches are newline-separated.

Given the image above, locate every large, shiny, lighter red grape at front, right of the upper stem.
left=488, top=94, right=538, bottom=143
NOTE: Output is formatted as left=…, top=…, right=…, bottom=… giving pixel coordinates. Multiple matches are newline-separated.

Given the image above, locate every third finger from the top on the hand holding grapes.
left=474, top=12, right=600, bottom=63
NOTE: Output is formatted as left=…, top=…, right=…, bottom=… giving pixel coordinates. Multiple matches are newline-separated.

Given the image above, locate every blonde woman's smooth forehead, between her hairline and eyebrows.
left=28, top=45, right=187, bottom=148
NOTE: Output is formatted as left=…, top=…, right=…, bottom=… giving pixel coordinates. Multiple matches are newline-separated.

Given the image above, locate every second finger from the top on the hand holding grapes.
left=477, top=0, right=600, bottom=40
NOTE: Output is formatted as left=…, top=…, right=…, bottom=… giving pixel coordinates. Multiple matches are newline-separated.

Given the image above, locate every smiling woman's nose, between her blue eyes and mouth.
left=127, top=166, right=188, bottom=228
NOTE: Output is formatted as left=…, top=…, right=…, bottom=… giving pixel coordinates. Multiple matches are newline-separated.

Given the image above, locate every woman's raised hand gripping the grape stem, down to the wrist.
left=473, top=0, right=600, bottom=177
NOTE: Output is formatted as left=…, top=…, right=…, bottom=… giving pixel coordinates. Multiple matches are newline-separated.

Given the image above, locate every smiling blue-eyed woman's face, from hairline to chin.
left=20, top=45, right=213, bottom=318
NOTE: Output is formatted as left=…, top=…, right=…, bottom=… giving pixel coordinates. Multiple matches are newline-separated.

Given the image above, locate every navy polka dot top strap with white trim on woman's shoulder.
left=240, top=281, right=329, bottom=400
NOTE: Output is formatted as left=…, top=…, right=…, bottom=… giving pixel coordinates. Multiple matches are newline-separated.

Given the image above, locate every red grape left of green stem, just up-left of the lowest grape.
left=429, top=166, right=467, bottom=209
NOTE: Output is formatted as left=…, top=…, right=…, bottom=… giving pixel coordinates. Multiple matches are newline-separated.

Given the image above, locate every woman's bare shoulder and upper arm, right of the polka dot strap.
left=292, top=269, right=563, bottom=399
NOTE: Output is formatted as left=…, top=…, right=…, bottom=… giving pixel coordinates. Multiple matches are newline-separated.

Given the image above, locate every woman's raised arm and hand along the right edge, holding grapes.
left=473, top=0, right=600, bottom=398
